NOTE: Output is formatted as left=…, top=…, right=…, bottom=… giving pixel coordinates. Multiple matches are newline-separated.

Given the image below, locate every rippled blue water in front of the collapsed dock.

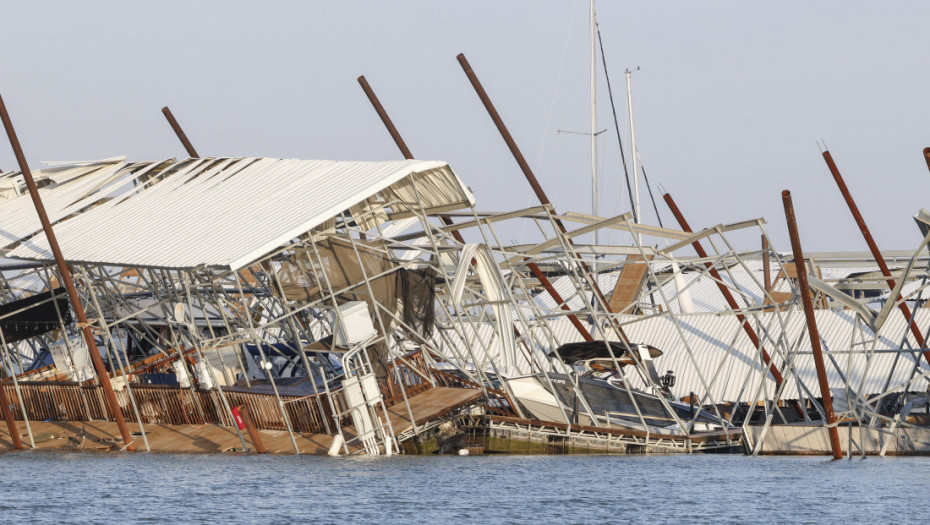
left=0, top=451, right=930, bottom=525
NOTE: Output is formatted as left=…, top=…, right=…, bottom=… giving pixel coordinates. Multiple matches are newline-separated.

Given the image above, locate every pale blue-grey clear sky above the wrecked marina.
left=0, top=0, right=930, bottom=252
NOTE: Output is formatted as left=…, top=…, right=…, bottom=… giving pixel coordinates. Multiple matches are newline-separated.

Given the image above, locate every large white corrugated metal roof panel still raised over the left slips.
left=0, top=158, right=474, bottom=269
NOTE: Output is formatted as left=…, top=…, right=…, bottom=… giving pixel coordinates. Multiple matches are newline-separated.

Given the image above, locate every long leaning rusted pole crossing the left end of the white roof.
left=0, top=91, right=136, bottom=451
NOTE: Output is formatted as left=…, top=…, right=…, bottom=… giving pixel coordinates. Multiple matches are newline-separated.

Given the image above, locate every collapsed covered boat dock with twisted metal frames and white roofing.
left=0, top=56, right=930, bottom=457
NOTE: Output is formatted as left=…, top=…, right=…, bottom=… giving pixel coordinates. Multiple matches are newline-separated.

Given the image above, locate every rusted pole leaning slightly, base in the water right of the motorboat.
left=781, top=190, right=843, bottom=459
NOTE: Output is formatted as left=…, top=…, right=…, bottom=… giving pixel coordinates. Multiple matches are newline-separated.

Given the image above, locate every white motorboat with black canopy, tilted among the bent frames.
left=507, top=341, right=730, bottom=434
